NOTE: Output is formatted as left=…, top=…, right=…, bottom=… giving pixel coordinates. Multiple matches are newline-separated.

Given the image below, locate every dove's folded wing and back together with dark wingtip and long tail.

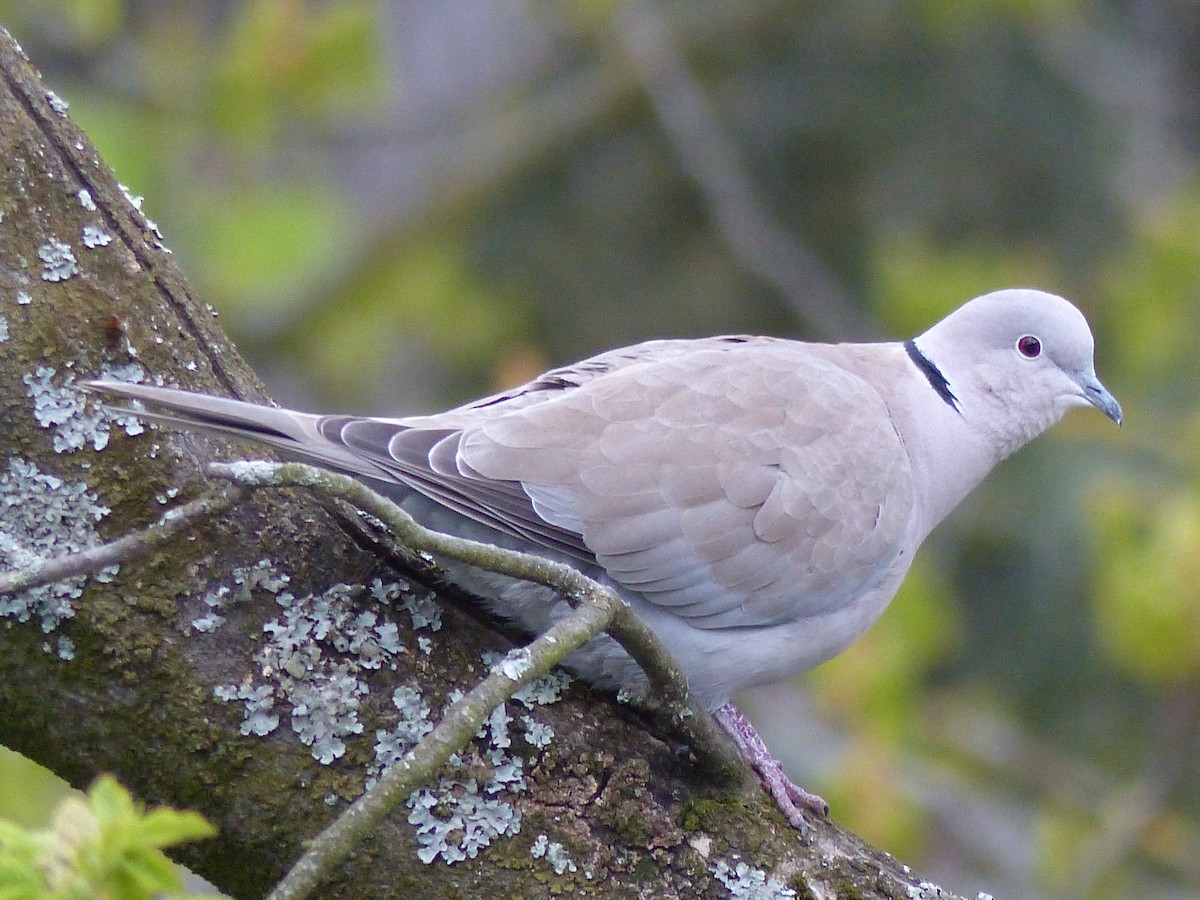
left=91, top=337, right=913, bottom=628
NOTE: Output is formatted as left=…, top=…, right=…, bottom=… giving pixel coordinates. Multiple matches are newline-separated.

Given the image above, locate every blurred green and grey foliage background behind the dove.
left=0, top=0, right=1200, bottom=898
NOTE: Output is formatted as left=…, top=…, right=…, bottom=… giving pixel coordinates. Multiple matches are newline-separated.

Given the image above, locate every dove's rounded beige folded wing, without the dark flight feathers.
left=446, top=338, right=913, bottom=628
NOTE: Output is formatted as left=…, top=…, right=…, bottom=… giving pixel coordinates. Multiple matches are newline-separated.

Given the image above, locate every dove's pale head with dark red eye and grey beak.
left=916, top=289, right=1121, bottom=445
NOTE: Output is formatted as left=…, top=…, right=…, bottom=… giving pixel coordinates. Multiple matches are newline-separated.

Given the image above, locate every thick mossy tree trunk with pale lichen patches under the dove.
left=0, top=32, right=950, bottom=898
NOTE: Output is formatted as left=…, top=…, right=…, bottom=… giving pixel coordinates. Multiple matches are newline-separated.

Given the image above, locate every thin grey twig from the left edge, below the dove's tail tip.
left=0, top=484, right=246, bottom=594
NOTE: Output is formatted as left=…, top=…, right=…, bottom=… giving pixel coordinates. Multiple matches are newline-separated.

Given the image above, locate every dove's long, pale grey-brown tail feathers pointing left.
left=82, top=380, right=392, bottom=480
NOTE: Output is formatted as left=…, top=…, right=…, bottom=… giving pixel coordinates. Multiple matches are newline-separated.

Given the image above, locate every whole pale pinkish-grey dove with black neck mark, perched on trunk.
left=89, top=289, right=1122, bottom=830
